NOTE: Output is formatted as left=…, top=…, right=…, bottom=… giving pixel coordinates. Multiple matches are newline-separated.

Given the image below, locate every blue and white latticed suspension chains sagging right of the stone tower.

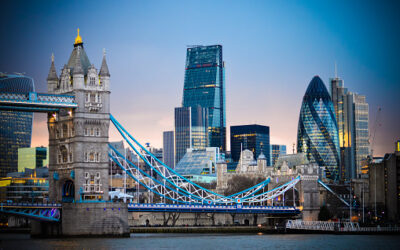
left=109, top=115, right=300, bottom=204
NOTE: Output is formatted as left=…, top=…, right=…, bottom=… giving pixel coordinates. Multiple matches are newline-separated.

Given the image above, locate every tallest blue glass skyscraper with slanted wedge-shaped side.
left=182, top=45, right=226, bottom=151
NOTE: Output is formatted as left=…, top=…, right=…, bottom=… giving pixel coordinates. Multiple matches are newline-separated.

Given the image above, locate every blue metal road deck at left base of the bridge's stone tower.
left=0, top=203, right=61, bottom=222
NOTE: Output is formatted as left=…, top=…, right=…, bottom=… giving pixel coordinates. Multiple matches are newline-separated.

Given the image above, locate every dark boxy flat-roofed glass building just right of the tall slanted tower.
left=231, top=124, right=271, bottom=166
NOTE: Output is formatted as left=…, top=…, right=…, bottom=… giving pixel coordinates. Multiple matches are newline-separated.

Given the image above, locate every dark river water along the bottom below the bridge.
left=0, top=234, right=400, bottom=250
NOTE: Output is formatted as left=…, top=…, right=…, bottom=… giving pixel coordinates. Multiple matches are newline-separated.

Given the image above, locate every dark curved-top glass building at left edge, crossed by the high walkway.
left=0, top=74, right=34, bottom=177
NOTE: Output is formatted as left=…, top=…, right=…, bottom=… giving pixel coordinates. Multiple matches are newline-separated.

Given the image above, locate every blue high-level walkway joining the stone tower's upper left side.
left=0, top=92, right=78, bottom=112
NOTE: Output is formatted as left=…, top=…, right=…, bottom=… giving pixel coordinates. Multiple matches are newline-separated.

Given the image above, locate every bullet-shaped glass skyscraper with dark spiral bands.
left=297, top=76, right=340, bottom=180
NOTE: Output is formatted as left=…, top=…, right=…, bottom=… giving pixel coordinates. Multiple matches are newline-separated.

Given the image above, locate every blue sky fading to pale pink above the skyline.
left=0, top=0, right=400, bottom=155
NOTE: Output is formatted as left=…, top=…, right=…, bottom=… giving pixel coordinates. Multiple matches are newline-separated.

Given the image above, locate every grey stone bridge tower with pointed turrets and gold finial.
left=47, top=29, right=110, bottom=202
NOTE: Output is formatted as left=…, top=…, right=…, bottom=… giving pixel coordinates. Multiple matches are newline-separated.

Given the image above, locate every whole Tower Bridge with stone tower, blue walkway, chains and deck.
left=0, top=30, right=346, bottom=235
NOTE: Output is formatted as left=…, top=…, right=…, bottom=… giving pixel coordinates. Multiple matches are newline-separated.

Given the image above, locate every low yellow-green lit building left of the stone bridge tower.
left=18, top=147, right=49, bottom=172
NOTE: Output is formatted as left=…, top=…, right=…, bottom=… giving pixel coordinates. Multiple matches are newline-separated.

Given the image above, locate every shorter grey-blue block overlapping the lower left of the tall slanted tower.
left=175, top=106, right=209, bottom=165
